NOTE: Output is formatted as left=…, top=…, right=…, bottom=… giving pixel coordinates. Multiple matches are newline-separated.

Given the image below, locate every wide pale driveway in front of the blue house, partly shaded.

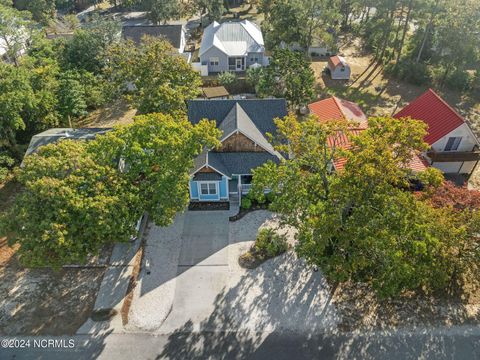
left=128, top=211, right=338, bottom=334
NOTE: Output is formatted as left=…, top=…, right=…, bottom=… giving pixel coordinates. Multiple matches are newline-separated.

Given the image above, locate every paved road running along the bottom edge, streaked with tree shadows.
left=0, top=327, right=480, bottom=360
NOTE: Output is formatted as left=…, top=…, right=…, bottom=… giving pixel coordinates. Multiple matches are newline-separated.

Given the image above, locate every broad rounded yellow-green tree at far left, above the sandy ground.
left=2, top=140, right=142, bottom=267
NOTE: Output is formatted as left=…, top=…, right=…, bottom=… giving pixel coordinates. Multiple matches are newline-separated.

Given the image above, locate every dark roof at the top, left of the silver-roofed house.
left=122, top=25, right=182, bottom=49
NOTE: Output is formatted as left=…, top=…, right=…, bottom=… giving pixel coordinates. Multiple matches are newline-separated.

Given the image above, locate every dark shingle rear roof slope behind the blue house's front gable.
left=187, top=99, right=287, bottom=136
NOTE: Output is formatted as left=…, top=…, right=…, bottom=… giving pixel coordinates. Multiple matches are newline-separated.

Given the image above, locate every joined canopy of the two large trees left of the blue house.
left=0, top=114, right=220, bottom=267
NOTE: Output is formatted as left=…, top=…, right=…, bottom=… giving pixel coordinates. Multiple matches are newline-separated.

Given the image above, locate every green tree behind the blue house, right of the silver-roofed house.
left=257, top=49, right=316, bottom=108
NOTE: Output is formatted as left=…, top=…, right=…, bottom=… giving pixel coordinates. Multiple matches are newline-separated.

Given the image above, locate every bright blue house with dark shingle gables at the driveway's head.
left=187, top=99, right=287, bottom=201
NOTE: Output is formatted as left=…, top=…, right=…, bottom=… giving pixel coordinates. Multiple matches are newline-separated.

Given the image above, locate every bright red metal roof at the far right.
left=394, top=89, right=465, bottom=145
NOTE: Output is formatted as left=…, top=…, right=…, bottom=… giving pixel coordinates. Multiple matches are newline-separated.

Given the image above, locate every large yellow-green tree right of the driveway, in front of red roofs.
left=252, top=116, right=478, bottom=296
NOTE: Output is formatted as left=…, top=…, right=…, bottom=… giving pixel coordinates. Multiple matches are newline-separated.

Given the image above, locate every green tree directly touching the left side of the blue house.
left=94, top=114, right=220, bottom=226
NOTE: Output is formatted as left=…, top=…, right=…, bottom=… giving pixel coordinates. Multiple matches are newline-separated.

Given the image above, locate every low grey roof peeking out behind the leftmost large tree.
left=25, top=128, right=111, bottom=156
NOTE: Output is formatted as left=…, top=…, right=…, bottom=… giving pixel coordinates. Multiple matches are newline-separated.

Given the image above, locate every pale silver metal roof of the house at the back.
left=199, top=20, right=265, bottom=56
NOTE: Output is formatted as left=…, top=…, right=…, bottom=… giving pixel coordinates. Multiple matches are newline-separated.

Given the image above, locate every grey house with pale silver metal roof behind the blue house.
left=199, top=20, right=267, bottom=74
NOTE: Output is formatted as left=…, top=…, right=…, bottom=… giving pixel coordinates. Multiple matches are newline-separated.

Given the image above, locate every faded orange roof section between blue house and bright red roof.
left=308, top=96, right=368, bottom=128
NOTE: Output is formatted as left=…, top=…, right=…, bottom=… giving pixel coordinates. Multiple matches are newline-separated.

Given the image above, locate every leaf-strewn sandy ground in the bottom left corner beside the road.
left=0, top=267, right=104, bottom=335
